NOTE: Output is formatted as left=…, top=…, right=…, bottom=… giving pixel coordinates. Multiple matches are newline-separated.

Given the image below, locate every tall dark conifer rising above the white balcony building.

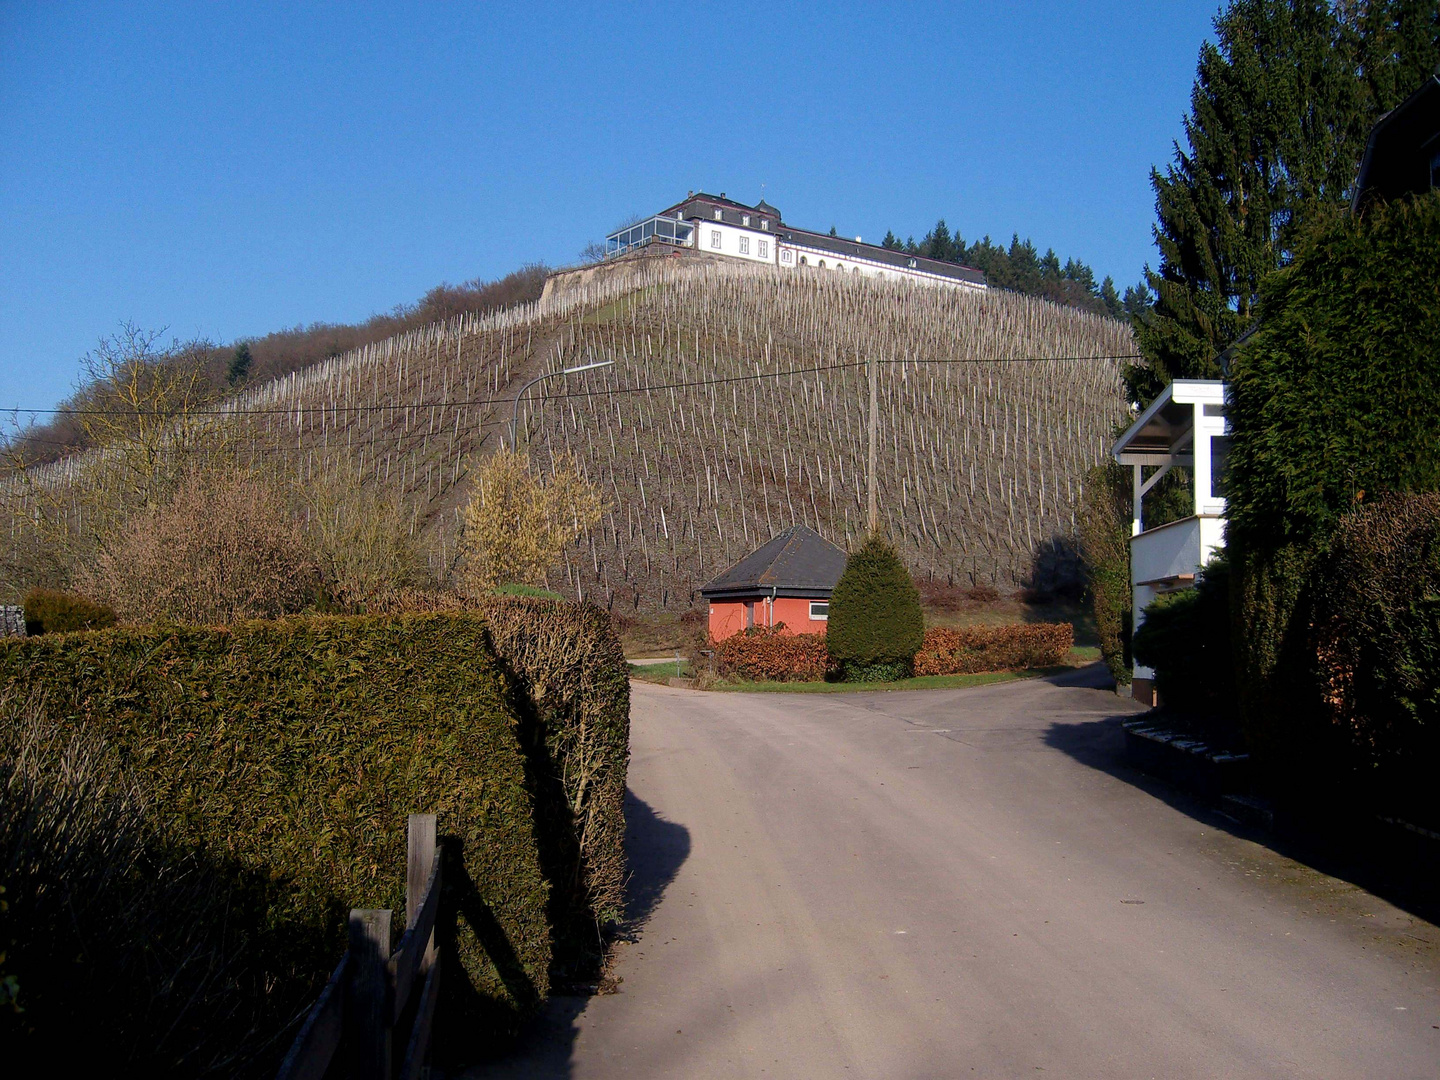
left=1126, top=0, right=1440, bottom=405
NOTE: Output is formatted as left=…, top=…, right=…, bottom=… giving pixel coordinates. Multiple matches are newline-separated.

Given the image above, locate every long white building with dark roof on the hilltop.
left=605, top=192, right=986, bottom=289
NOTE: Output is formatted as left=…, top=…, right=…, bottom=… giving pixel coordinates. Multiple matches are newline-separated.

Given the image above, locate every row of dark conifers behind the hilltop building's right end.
left=869, top=217, right=1149, bottom=318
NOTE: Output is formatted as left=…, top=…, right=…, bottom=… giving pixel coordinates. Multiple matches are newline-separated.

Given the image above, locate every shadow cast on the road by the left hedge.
left=458, top=788, right=690, bottom=1080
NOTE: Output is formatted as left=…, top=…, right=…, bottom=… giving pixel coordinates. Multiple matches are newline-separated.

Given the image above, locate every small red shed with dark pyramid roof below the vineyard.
left=700, top=526, right=845, bottom=641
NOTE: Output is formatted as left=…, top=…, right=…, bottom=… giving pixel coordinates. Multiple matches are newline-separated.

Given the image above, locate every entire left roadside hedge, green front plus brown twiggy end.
left=0, top=600, right=628, bottom=1073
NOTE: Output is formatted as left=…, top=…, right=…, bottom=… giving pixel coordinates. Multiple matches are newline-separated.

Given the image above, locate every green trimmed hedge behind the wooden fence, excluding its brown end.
left=0, top=613, right=550, bottom=1074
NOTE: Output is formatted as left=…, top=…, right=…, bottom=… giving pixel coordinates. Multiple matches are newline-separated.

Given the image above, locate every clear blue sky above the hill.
left=0, top=0, right=1218, bottom=409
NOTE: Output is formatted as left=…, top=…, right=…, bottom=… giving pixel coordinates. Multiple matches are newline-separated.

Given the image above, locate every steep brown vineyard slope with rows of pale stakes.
left=10, top=259, right=1133, bottom=612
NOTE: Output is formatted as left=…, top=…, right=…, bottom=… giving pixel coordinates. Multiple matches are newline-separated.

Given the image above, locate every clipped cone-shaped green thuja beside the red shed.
left=825, top=536, right=924, bottom=683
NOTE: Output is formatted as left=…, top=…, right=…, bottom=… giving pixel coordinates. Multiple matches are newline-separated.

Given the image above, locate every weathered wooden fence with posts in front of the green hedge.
left=276, top=814, right=441, bottom=1080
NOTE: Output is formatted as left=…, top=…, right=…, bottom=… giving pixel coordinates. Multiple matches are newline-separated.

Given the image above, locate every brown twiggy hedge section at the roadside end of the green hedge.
left=481, top=596, right=629, bottom=982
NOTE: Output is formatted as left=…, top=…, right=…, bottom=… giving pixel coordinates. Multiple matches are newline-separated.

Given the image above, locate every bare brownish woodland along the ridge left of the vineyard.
left=0, top=264, right=550, bottom=468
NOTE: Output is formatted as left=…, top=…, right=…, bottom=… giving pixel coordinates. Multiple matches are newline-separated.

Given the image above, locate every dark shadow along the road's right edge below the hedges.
left=1044, top=711, right=1440, bottom=923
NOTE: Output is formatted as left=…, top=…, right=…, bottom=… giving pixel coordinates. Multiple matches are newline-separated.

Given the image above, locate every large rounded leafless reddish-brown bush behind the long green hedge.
left=78, top=471, right=321, bottom=624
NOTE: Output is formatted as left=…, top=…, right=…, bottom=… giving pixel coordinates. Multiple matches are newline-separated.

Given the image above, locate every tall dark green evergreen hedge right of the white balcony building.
left=1225, top=192, right=1440, bottom=772
